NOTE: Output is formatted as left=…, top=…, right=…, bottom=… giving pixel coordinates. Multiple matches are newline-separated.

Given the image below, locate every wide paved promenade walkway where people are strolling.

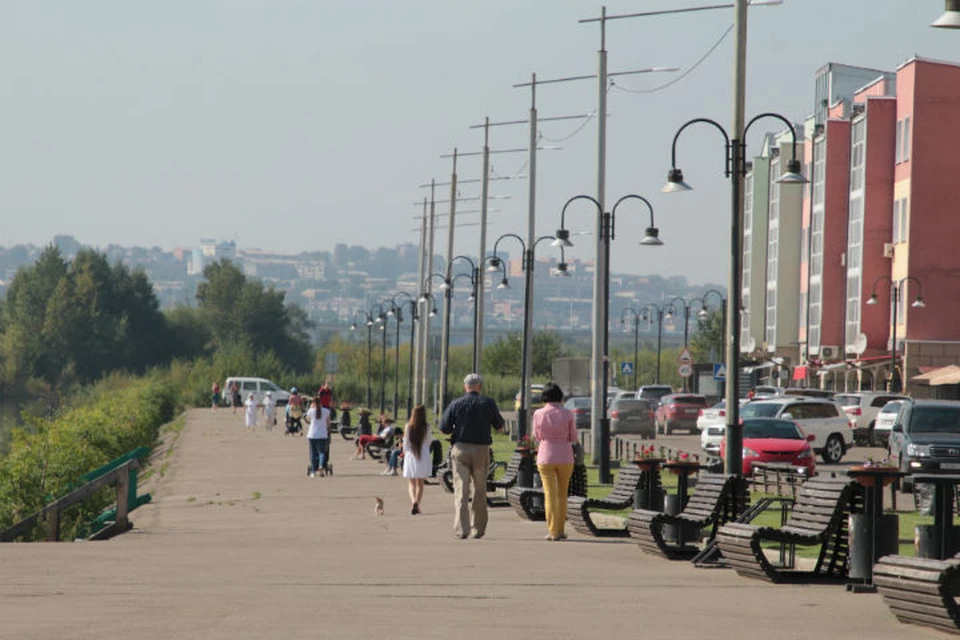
left=0, top=410, right=941, bottom=640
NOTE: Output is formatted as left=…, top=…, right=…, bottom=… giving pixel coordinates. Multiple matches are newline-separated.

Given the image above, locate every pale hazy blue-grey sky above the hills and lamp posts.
left=0, top=0, right=960, bottom=284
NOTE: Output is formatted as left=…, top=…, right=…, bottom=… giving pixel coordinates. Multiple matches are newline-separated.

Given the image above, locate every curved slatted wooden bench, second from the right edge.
left=717, top=476, right=863, bottom=582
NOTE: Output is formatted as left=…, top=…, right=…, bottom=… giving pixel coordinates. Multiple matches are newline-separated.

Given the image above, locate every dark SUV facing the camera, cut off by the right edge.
left=889, top=399, right=960, bottom=491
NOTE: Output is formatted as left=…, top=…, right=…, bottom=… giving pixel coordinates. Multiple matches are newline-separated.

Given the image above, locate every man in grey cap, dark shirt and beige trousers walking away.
left=440, top=373, right=504, bottom=540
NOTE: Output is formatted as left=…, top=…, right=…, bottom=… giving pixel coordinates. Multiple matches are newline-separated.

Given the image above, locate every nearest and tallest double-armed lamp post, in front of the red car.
left=662, top=111, right=807, bottom=476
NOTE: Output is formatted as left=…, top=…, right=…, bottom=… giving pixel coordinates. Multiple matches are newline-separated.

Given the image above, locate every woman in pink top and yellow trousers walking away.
left=533, top=382, right=577, bottom=540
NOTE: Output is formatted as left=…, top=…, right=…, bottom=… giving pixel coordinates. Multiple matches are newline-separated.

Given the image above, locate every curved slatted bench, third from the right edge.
left=627, top=473, right=746, bottom=560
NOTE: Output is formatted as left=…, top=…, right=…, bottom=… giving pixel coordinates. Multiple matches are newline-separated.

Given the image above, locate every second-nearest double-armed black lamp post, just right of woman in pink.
left=553, top=194, right=663, bottom=483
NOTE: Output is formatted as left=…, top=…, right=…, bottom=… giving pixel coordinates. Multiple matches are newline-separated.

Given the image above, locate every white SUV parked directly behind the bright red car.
left=740, top=396, right=854, bottom=463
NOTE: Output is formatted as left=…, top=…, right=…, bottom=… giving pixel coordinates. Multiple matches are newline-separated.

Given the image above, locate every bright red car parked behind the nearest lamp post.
left=720, top=418, right=817, bottom=477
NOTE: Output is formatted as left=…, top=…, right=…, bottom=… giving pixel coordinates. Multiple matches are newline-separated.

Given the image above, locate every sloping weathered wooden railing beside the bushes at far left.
left=0, top=458, right=140, bottom=542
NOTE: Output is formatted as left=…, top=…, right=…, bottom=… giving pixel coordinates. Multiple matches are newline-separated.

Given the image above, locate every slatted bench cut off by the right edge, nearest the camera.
left=873, top=555, right=960, bottom=633
